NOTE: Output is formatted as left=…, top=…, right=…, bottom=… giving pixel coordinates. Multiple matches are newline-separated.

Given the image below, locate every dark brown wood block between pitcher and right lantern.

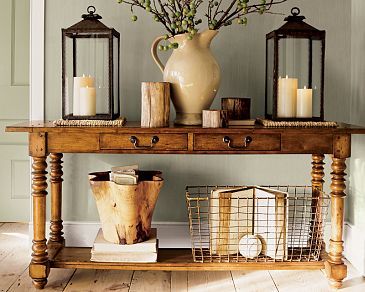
left=221, top=97, right=251, bottom=120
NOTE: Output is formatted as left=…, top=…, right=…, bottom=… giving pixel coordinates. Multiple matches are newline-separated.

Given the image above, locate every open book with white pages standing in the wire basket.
left=209, top=186, right=288, bottom=259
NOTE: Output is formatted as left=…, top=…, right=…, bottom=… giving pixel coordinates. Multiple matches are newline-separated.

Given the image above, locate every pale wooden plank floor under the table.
left=0, top=223, right=365, bottom=292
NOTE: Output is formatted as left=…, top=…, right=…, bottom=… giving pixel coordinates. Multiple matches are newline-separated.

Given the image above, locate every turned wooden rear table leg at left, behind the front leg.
left=49, top=153, right=65, bottom=245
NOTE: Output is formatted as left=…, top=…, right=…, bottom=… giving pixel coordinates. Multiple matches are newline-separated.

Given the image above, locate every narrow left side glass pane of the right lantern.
left=266, top=38, right=275, bottom=115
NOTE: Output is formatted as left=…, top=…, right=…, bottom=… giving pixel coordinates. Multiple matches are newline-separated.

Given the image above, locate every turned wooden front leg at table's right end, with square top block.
left=325, top=135, right=351, bottom=288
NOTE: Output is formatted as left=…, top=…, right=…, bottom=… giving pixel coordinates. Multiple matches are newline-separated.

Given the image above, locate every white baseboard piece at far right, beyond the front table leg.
left=344, top=222, right=365, bottom=276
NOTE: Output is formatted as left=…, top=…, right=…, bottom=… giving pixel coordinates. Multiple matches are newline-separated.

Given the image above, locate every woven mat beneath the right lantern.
left=256, top=119, right=338, bottom=128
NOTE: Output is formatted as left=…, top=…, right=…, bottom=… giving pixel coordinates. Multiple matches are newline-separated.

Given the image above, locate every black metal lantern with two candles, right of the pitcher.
left=265, top=7, right=326, bottom=121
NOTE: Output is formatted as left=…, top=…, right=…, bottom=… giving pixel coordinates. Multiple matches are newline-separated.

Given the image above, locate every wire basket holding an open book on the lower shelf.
left=186, top=186, right=330, bottom=263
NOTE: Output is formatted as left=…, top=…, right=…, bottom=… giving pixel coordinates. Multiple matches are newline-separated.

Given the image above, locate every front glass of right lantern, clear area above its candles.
left=278, top=37, right=311, bottom=88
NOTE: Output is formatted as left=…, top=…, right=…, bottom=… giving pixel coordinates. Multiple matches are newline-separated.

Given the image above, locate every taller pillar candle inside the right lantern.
left=277, top=76, right=298, bottom=118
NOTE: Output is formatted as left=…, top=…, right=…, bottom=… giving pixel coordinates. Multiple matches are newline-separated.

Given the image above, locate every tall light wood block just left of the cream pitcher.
left=141, top=82, right=170, bottom=128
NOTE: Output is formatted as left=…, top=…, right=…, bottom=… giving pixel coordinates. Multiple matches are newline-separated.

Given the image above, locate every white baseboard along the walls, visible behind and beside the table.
left=29, top=221, right=365, bottom=275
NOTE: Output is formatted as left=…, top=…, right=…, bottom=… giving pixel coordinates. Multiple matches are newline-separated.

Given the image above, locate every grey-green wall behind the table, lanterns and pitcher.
left=45, top=0, right=351, bottom=221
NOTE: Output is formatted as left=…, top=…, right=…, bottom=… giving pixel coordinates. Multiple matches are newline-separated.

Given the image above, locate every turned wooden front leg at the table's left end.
left=29, top=156, right=49, bottom=289
